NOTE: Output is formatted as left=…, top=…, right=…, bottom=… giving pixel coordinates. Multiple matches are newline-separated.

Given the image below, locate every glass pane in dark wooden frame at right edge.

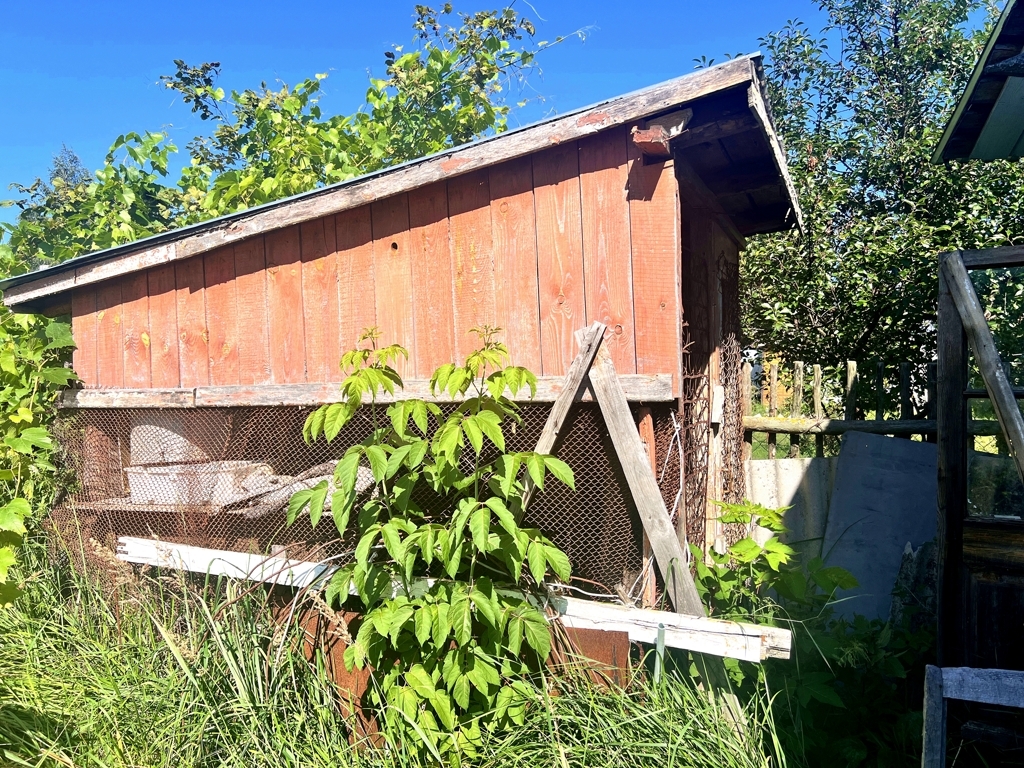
left=967, top=399, right=1024, bottom=519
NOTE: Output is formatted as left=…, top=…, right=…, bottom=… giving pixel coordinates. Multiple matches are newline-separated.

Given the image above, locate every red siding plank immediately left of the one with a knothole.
left=335, top=206, right=377, bottom=360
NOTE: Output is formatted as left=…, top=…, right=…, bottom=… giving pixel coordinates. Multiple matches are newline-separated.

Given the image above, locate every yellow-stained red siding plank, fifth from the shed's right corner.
left=447, top=171, right=497, bottom=360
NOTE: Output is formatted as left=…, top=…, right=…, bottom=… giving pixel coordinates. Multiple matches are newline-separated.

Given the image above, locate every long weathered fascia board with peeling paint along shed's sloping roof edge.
left=0, top=53, right=761, bottom=307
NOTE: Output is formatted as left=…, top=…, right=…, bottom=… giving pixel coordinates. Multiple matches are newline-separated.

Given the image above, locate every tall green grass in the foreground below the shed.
left=0, top=540, right=778, bottom=768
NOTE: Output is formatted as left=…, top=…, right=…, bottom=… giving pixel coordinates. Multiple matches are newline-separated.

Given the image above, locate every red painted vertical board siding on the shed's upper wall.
left=72, top=128, right=696, bottom=387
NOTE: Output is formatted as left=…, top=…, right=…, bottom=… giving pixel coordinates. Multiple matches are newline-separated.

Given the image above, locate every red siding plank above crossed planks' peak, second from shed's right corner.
left=580, top=126, right=637, bottom=374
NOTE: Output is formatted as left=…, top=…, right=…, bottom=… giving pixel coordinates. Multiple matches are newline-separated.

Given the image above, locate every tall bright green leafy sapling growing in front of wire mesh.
left=289, top=328, right=573, bottom=758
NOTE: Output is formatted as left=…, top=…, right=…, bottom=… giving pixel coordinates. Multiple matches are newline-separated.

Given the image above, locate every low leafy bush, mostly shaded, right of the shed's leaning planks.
left=694, top=503, right=935, bottom=766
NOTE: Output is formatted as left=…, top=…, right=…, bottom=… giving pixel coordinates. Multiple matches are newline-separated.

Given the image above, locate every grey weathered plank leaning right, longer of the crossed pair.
left=590, top=347, right=705, bottom=616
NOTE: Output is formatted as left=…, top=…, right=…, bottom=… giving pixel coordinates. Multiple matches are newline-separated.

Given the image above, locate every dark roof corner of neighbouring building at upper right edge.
left=932, top=0, right=1024, bottom=163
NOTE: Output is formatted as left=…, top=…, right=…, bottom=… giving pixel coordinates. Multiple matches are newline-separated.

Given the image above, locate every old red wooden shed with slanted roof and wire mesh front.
left=0, top=55, right=800, bottom=593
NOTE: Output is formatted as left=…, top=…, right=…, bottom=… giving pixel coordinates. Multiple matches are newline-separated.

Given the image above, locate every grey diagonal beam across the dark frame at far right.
left=942, top=253, right=1024, bottom=482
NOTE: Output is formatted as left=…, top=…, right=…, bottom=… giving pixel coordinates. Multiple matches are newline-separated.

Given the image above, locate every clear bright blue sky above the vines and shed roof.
left=0, top=0, right=821, bottom=220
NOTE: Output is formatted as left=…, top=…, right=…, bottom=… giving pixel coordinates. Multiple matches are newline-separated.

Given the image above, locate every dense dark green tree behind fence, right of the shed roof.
left=742, top=0, right=1024, bottom=365
